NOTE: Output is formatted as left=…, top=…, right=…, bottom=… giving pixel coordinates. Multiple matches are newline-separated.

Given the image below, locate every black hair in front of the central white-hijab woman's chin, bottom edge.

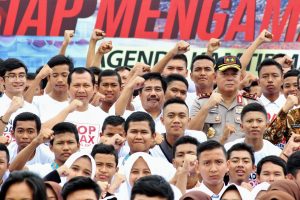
left=130, top=175, right=174, bottom=200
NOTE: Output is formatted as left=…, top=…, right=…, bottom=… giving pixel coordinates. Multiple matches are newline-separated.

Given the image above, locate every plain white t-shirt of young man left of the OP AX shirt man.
left=32, top=94, right=69, bottom=123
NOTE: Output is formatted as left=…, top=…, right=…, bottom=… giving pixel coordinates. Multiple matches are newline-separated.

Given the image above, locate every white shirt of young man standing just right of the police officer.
left=259, top=94, right=286, bottom=121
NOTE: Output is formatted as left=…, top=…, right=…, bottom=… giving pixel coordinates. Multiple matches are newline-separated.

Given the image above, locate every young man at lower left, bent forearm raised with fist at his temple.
left=10, top=122, right=80, bottom=178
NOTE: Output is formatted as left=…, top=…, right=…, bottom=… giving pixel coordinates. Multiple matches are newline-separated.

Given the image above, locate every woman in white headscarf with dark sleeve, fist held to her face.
left=44, top=151, right=96, bottom=186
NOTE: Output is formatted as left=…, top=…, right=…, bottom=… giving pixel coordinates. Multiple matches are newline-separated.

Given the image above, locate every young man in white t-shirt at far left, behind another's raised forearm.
left=8, top=112, right=54, bottom=165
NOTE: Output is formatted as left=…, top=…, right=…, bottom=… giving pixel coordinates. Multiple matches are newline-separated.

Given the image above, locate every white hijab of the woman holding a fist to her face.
left=60, top=151, right=96, bottom=186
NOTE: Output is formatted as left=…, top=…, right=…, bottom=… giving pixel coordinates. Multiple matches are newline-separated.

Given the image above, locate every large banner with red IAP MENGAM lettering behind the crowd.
left=0, top=0, right=300, bottom=71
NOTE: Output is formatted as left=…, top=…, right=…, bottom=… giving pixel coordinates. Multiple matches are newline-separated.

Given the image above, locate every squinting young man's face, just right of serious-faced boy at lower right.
left=227, top=151, right=255, bottom=185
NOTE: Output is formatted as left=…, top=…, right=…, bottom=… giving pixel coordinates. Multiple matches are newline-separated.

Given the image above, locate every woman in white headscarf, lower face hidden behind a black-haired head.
left=116, top=152, right=181, bottom=200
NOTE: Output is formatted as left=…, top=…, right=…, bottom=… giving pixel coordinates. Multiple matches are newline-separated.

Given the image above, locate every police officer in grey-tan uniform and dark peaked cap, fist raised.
left=189, top=56, right=258, bottom=142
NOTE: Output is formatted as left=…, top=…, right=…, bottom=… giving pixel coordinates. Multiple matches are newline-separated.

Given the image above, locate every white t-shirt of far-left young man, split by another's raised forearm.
left=7, top=142, right=54, bottom=165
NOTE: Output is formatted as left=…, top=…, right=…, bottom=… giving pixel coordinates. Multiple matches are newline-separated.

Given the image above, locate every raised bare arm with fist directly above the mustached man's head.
left=151, top=40, right=190, bottom=73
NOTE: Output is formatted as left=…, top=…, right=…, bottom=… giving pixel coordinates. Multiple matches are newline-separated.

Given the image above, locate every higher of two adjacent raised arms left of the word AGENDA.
left=85, top=29, right=105, bottom=68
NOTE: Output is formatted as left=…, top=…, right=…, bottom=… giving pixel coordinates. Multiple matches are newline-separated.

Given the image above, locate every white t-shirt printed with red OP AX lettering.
left=65, top=104, right=108, bottom=148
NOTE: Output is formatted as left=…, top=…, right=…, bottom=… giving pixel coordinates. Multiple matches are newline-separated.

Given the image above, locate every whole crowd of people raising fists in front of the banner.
left=0, top=29, right=300, bottom=200
